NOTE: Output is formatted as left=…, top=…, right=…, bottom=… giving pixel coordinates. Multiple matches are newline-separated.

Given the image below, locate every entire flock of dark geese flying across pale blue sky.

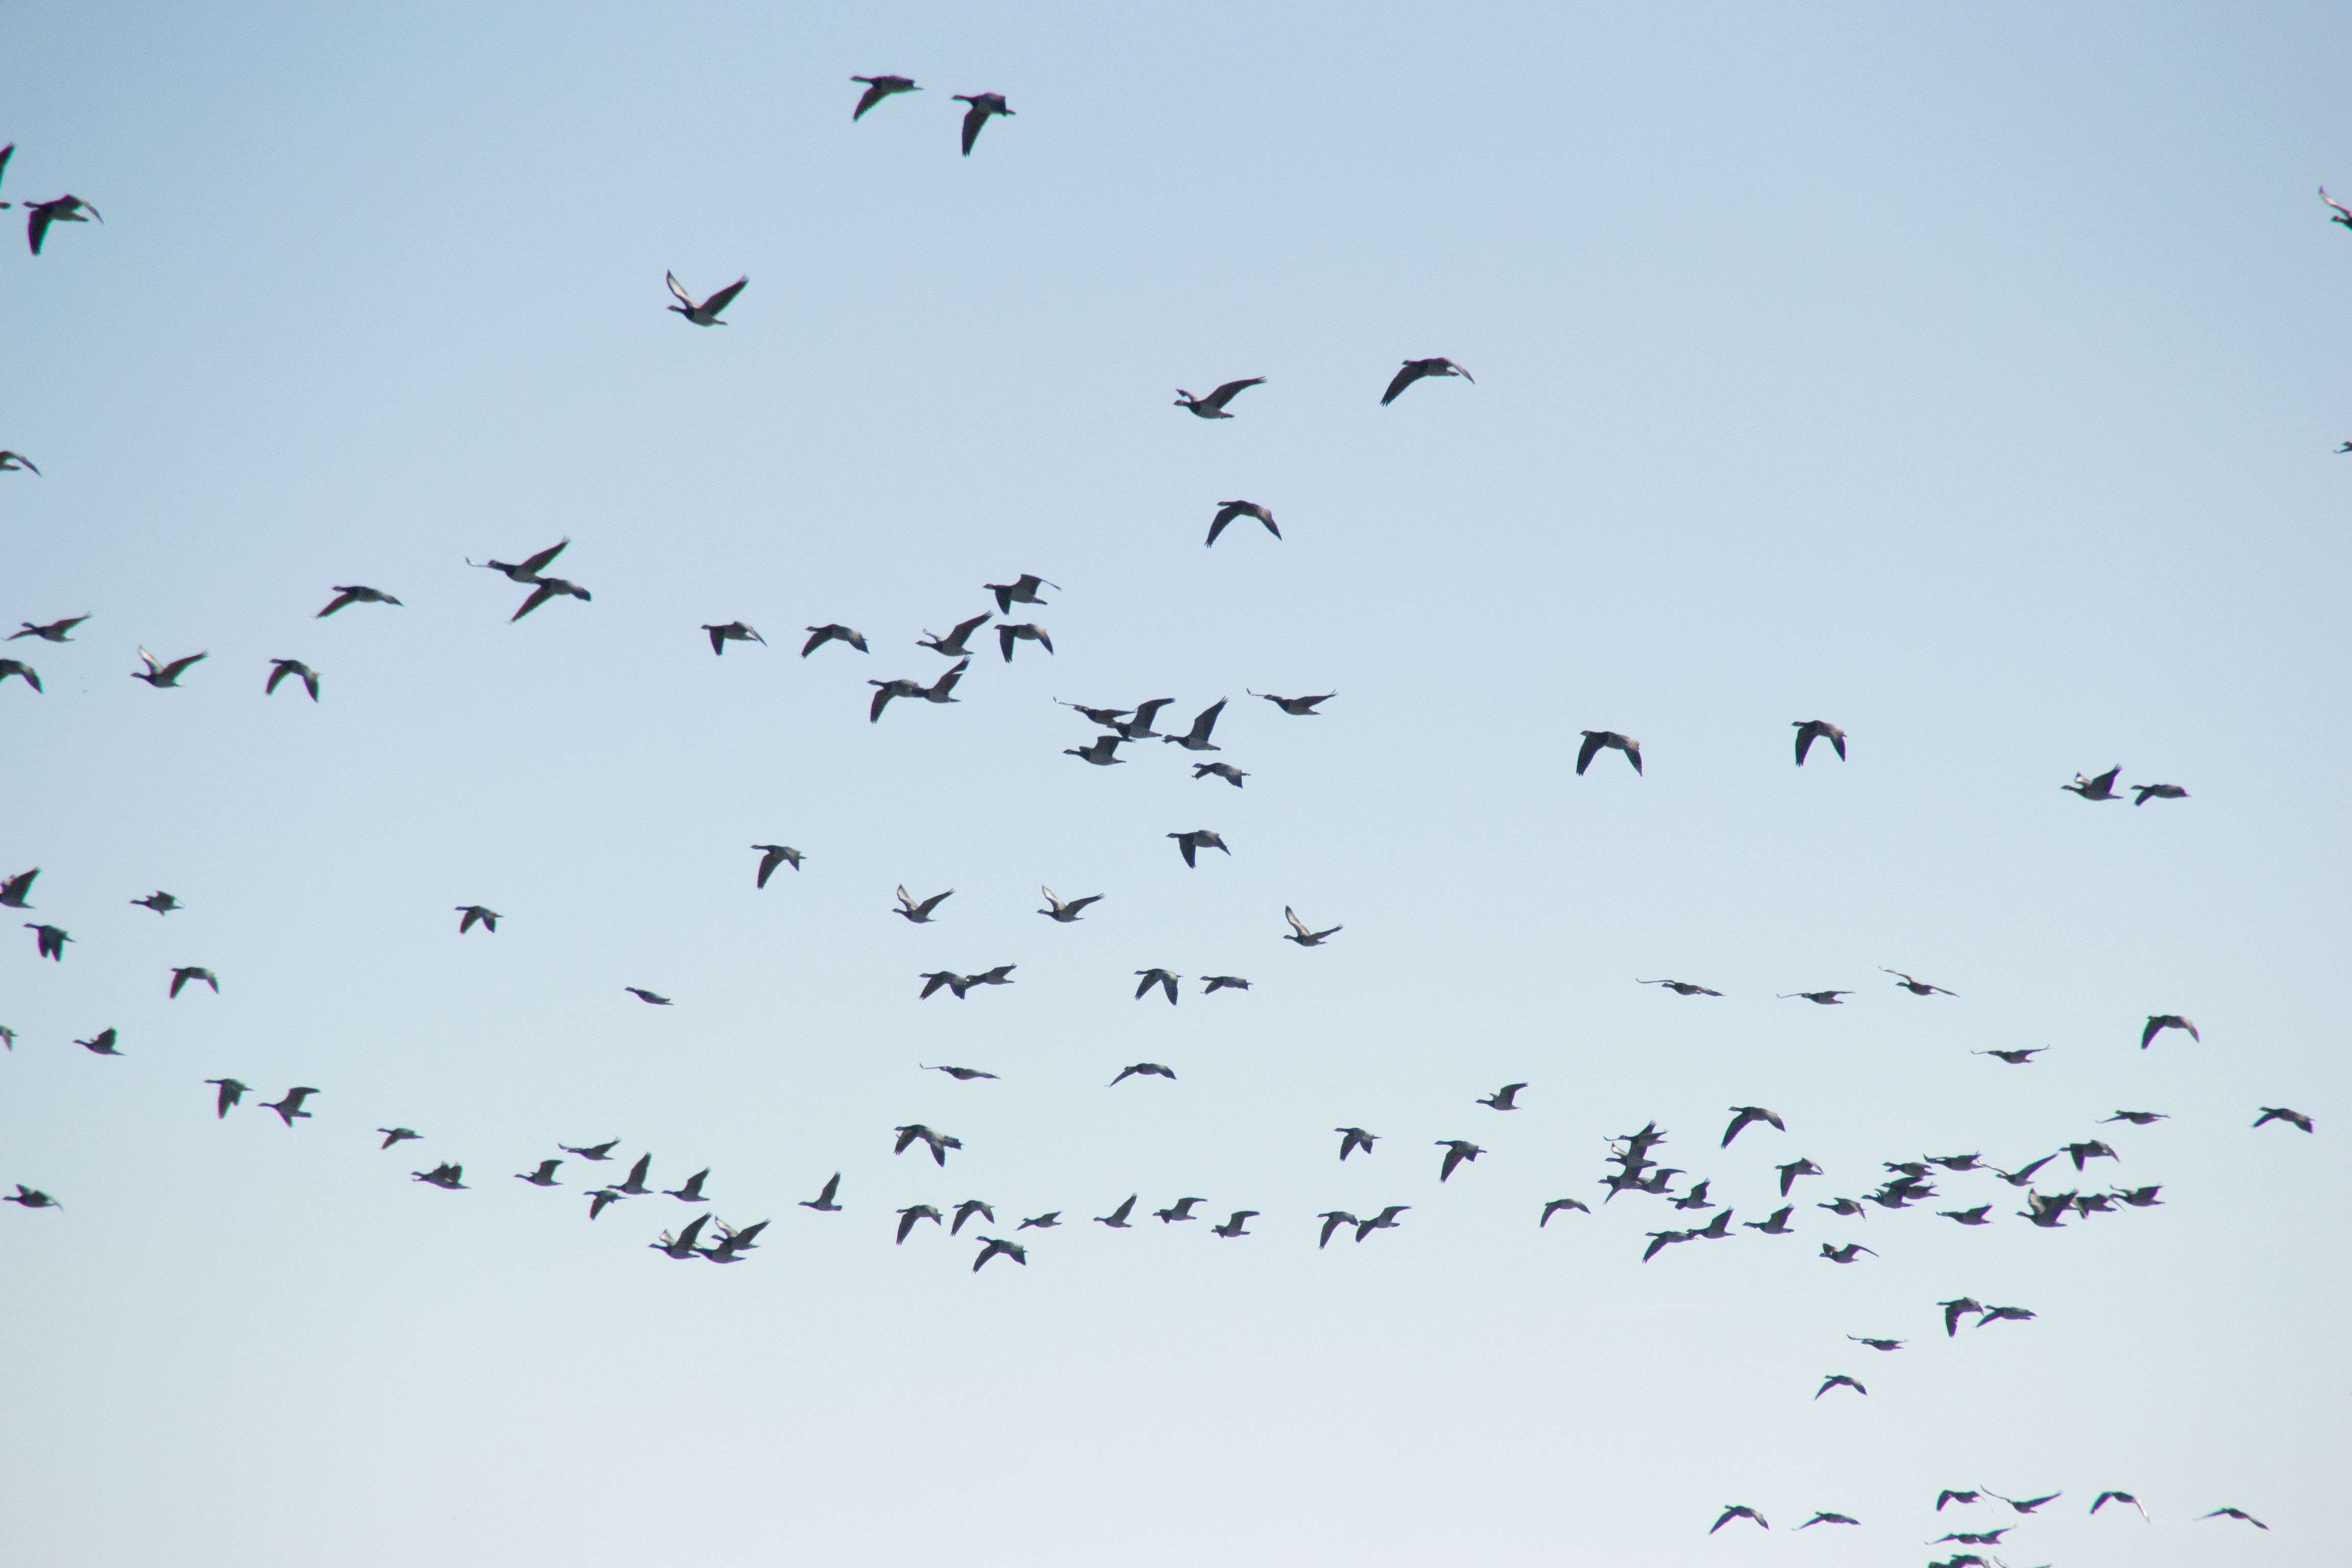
left=0, top=92, right=2352, bottom=1568
